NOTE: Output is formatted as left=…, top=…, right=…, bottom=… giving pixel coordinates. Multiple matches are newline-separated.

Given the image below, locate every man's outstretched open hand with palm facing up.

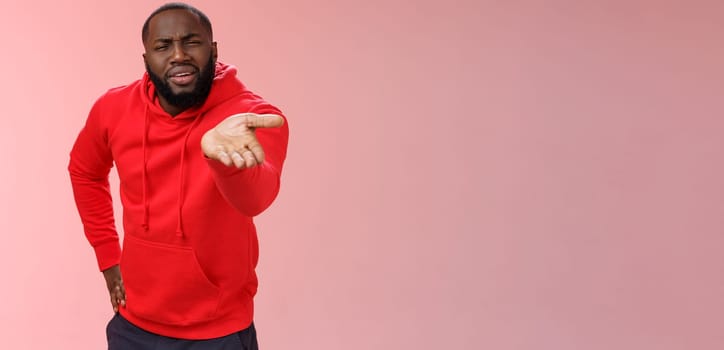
left=201, top=113, right=284, bottom=169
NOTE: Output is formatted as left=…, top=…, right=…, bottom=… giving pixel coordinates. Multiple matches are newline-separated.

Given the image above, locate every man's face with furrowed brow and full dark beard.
left=143, top=10, right=217, bottom=114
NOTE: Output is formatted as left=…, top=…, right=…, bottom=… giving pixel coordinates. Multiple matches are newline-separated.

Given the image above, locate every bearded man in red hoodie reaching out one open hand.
left=68, top=3, right=289, bottom=350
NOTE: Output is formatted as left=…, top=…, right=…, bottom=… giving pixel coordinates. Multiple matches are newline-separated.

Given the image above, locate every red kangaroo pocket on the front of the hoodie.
left=121, top=235, right=220, bottom=325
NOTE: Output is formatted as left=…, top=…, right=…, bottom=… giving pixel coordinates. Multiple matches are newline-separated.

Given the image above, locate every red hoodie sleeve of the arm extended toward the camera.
left=206, top=102, right=289, bottom=216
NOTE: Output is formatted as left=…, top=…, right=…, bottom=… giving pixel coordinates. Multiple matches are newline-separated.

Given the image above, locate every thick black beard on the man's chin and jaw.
left=146, top=57, right=216, bottom=110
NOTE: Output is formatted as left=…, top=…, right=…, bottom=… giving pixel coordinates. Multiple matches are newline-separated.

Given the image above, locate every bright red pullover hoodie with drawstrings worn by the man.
left=68, top=63, right=289, bottom=339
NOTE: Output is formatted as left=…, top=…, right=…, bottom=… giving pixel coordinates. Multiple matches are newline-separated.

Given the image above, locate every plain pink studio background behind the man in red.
left=0, top=0, right=724, bottom=350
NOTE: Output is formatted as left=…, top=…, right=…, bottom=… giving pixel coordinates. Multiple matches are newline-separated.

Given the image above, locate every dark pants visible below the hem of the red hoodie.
left=106, top=314, right=259, bottom=350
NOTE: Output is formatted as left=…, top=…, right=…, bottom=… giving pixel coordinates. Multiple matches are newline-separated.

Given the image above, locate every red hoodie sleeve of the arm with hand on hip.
left=68, top=100, right=121, bottom=271
